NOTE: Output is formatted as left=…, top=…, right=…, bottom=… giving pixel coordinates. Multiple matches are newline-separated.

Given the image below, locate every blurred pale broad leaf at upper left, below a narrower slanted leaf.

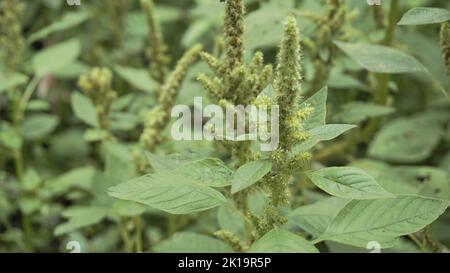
left=33, top=39, right=81, bottom=76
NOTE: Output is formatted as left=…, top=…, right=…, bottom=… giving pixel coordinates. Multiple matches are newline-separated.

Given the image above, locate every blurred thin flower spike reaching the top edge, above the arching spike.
left=141, top=0, right=170, bottom=84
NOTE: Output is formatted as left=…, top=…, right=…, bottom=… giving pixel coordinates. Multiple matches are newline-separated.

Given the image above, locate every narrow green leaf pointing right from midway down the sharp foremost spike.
left=294, top=124, right=357, bottom=153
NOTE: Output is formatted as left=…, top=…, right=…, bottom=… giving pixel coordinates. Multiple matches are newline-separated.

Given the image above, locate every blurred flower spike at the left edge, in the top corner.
left=0, top=0, right=25, bottom=71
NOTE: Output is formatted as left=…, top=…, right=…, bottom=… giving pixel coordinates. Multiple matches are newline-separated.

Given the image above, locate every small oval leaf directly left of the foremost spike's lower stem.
left=231, top=160, right=272, bottom=194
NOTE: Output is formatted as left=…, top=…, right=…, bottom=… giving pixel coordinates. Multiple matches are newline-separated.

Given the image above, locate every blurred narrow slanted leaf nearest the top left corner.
left=28, top=11, right=89, bottom=43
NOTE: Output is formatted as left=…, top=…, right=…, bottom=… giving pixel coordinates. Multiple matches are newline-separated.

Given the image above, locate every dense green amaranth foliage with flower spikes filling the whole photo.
left=0, top=0, right=450, bottom=253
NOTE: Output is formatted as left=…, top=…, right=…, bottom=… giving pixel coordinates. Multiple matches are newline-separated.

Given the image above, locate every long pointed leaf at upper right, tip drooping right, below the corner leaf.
left=335, top=41, right=427, bottom=73
